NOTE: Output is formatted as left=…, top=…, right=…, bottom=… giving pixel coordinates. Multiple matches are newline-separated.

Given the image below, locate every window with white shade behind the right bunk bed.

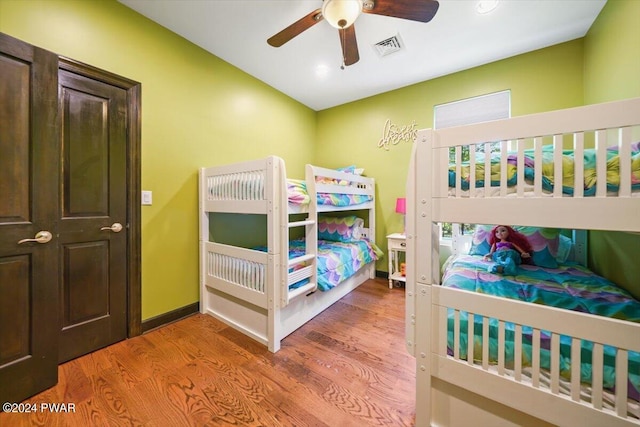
left=433, top=90, right=511, bottom=239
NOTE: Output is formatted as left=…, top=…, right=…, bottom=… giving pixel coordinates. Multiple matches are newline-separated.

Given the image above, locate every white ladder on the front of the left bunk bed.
left=278, top=159, right=318, bottom=307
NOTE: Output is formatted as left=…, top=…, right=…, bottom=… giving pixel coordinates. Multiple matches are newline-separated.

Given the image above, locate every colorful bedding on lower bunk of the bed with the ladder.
left=289, top=239, right=382, bottom=291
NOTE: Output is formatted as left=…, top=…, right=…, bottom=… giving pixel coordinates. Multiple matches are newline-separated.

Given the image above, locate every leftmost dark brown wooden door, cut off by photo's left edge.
left=0, top=34, right=59, bottom=402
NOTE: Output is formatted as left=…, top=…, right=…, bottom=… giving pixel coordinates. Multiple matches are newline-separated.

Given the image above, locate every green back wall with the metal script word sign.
left=316, top=39, right=583, bottom=271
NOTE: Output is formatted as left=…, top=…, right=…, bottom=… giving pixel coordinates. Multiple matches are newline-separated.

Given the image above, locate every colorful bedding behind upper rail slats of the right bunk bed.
left=449, top=142, right=640, bottom=196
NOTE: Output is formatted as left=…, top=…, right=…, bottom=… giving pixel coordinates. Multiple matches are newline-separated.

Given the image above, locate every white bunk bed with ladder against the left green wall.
left=199, top=156, right=375, bottom=352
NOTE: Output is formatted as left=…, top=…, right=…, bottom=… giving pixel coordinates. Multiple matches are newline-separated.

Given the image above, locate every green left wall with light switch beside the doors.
left=0, top=0, right=316, bottom=320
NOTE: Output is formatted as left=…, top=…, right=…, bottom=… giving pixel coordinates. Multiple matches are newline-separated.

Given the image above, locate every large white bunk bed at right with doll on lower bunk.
left=406, top=99, right=640, bottom=427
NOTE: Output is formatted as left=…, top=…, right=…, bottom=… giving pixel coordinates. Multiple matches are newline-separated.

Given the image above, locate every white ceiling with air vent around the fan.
left=119, top=0, right=606, bottom=111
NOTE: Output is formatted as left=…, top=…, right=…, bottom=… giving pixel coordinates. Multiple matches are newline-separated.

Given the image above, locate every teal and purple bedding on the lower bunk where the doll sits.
left=442, top=255, right=640, bottom=400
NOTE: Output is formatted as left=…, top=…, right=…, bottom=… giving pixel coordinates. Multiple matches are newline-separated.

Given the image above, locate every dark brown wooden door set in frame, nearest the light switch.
left=58, top=70, right=128, bottom=362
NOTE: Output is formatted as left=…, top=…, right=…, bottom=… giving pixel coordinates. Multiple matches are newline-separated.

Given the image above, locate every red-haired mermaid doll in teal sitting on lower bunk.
left=484, top=225, right=531, bottom=275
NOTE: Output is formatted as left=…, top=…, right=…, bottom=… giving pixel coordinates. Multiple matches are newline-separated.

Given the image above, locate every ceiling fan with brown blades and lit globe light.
left=267, top=0, right=440, bottom=67
